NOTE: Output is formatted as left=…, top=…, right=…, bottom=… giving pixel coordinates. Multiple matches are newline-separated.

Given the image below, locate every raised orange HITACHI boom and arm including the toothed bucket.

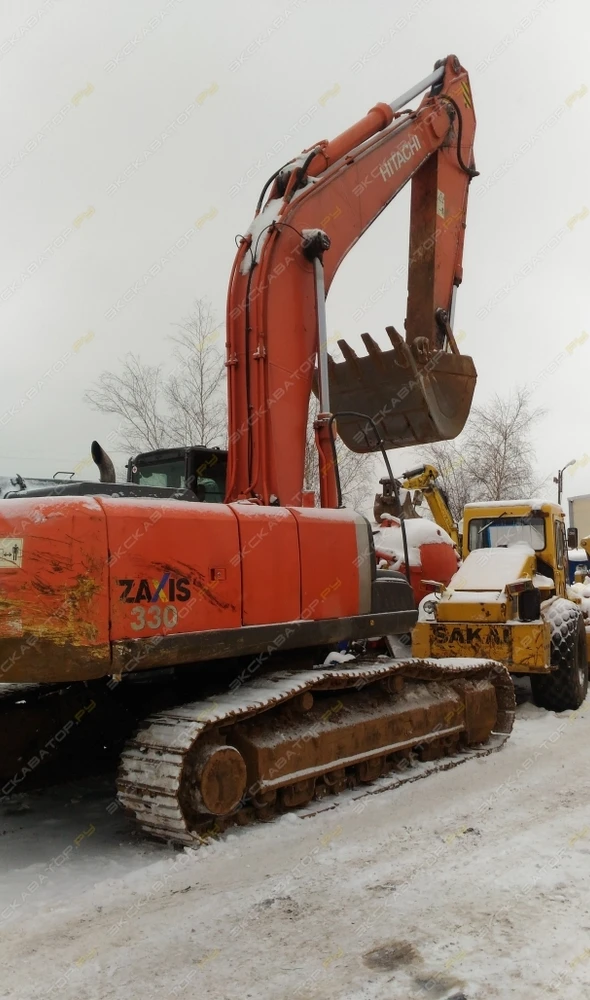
left=227, top=56, right=476, bottom=505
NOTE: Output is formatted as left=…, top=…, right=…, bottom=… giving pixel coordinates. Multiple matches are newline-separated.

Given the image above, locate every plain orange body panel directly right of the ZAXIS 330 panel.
left=230, top=503, right=301, bottom=625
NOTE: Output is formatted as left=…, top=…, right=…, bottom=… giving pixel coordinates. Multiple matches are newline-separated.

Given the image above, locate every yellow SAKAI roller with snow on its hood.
left=412, top=500, right=590, bottom=712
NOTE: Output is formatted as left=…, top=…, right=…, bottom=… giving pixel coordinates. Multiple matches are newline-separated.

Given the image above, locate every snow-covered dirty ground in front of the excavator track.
left=0, top=688, right=590, bottom=1000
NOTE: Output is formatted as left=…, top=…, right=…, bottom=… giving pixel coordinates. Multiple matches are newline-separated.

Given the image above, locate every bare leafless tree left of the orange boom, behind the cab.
left=85, top=300, right=226, bottom=452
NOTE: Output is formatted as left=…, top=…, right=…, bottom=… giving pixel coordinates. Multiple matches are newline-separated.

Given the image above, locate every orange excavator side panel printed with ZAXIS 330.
left=98, top=497, right=242, bottom=641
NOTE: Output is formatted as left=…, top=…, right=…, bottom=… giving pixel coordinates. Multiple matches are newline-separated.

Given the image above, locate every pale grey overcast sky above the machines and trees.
left=0, top=0, right=590, bottom=504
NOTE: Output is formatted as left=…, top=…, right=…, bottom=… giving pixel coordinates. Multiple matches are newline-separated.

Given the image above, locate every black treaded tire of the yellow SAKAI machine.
left=531, top=599, right=588, bottom=712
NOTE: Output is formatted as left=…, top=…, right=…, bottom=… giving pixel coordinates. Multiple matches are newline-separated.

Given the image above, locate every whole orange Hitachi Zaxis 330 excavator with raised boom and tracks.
left=0, top=56, right=514, bottom=844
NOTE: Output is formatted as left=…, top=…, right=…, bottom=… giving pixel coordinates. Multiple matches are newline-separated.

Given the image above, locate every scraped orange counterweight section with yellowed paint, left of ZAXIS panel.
left=0, top=497, right=110, bottom=683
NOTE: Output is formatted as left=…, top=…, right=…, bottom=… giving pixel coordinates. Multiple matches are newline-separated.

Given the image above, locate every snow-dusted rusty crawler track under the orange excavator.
left=117, top=657, right=515, bottom=845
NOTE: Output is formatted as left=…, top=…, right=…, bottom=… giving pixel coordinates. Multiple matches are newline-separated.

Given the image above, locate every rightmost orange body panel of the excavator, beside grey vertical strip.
left=289, top=507, right=373, bottom=620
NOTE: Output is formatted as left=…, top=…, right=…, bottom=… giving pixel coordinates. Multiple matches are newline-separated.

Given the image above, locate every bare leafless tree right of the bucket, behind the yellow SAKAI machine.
left=421, top=388, right=545, bottom=518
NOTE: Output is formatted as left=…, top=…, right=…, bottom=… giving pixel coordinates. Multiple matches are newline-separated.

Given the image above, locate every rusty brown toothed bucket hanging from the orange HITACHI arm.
left=328, top=327, right=477, bottom=453
